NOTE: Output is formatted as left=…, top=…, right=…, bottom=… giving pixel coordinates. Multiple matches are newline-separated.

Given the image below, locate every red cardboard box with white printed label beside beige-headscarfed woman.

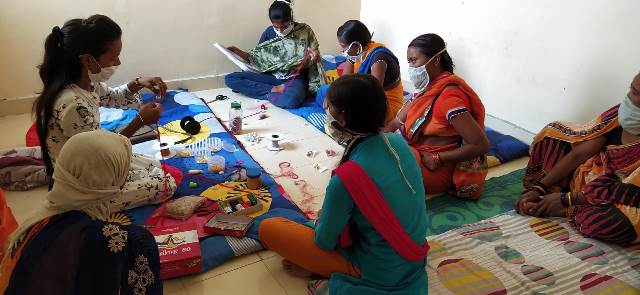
left=149, top=222, right=202, bottom=280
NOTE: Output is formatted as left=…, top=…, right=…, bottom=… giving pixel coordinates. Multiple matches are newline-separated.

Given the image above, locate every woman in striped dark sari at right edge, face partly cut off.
left=516, top=74, right=640, bottom=245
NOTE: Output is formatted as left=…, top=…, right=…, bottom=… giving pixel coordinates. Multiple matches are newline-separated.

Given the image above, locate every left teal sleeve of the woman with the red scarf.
left=314, top=176, right=354, bottom=250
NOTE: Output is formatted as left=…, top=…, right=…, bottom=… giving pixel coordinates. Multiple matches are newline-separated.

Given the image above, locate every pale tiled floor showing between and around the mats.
left=0, top=89, right=527, bottom=295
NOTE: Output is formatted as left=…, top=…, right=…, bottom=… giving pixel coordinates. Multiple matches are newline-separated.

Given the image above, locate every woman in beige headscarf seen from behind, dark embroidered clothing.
left=0, top=130, right=162, bottom=295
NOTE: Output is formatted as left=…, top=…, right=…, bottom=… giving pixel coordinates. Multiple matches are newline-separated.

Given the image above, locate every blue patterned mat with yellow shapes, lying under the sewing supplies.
left=112, top=90, right=307, bottom=271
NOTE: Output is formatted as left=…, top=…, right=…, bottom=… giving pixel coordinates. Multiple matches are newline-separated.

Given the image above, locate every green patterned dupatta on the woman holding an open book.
left=248, top=23, right=326, bottom=93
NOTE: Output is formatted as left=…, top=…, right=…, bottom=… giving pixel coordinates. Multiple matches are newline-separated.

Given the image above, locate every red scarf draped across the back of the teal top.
left=333, top=161, right=429, bottom=261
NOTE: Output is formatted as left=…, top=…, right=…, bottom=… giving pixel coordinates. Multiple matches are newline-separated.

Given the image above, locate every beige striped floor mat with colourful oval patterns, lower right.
left=426, top=211, right=640, bottom=295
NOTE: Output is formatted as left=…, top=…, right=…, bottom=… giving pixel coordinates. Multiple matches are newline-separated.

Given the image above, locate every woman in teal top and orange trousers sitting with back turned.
left=259, top=74, right=428, bottom=294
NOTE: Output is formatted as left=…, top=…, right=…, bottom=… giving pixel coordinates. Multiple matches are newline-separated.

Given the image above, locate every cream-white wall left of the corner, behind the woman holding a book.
left=0, top=0, right=360, bottom=99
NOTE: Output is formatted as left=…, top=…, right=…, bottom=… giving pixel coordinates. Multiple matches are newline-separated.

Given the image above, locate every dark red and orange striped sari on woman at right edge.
left=523, top=106, right=640, bottom=244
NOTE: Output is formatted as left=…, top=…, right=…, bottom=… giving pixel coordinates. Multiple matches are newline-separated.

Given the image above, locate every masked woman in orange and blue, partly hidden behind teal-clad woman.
left=322, top=20, right=404, bottom=123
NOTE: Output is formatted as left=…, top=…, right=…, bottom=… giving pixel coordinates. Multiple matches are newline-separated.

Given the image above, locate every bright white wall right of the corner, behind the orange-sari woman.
left=361, top=0, right=640, bottom=132
